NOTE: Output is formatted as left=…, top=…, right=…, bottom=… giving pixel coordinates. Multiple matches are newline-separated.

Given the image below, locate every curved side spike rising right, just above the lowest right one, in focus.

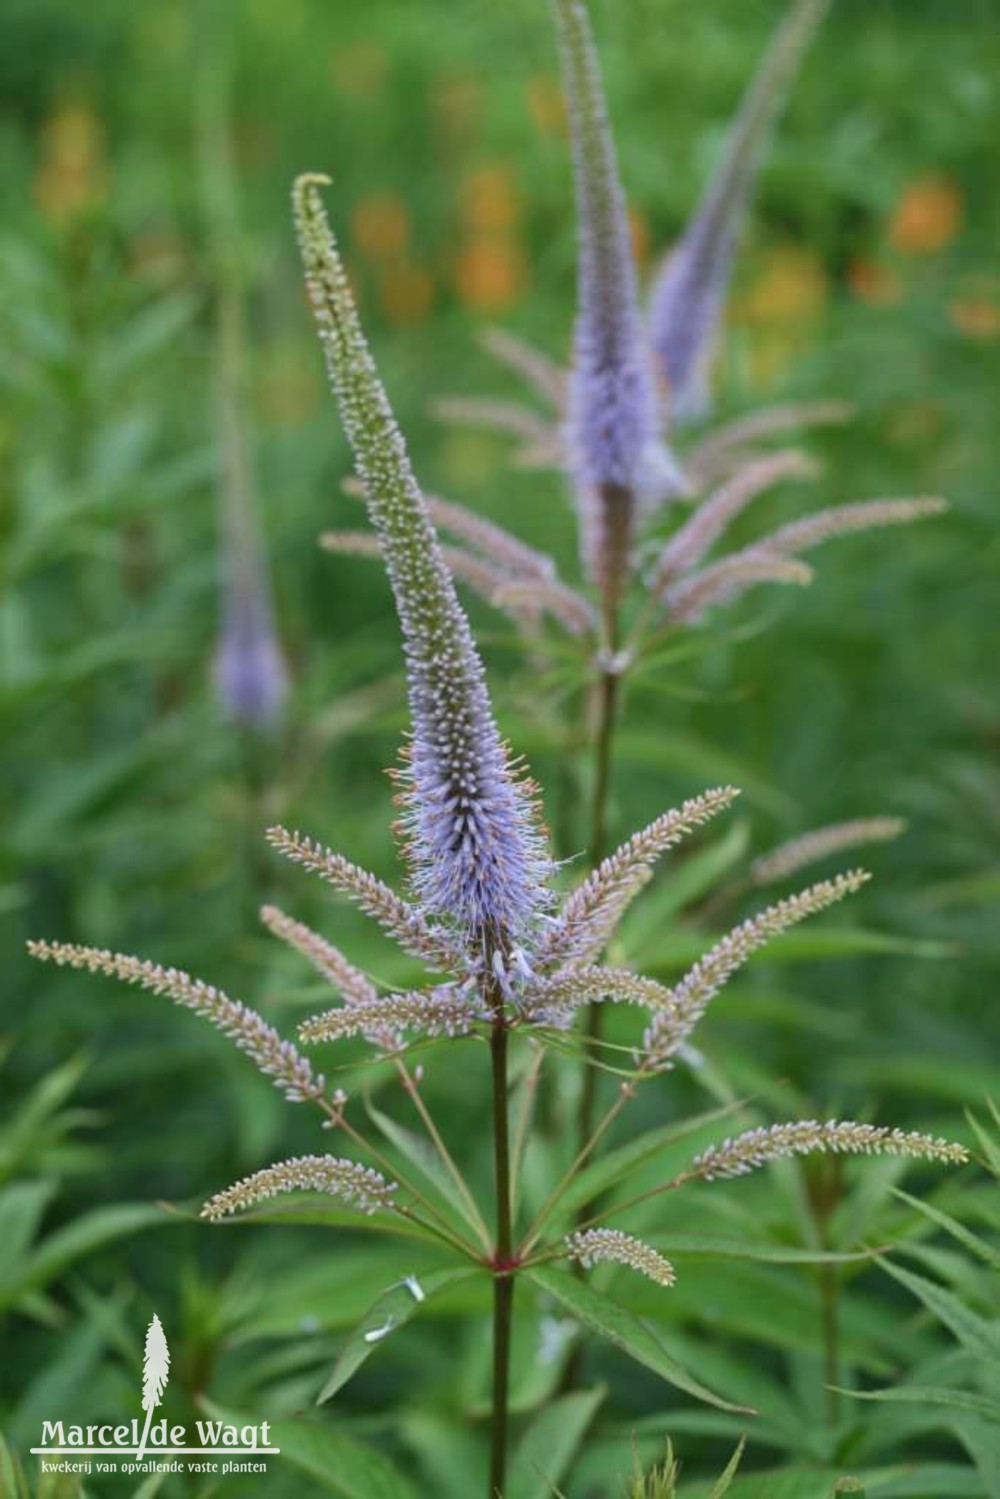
left=643, top=869, right=870, bottom=1067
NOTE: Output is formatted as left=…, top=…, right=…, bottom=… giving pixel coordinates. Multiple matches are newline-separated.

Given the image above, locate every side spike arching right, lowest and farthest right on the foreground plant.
left=684, top=1120, right=969, bottom=1181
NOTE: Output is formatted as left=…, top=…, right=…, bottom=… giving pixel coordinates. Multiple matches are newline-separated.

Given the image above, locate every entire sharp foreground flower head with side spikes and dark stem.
left=30, top=177, right=964, bottom=1493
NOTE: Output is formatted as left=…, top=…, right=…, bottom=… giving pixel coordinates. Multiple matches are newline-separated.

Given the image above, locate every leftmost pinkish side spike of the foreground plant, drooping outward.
left=27, top=941, right=325, bottom=1103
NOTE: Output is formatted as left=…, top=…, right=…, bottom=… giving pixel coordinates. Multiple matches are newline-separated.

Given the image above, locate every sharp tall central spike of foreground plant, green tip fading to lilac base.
left=294, top=177, right=550, bottom=940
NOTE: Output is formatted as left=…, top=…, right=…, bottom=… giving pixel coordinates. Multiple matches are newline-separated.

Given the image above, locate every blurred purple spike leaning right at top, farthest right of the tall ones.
left=649, top=0, right=829, bottom=423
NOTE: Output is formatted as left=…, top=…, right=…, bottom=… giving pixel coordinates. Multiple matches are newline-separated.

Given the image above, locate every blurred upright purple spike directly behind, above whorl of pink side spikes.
left=555, top=0, right=684, bottom=606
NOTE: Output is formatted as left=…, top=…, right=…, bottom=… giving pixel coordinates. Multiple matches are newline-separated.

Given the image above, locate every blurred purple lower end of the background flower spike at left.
left=214, top=577, right=288, bottom=729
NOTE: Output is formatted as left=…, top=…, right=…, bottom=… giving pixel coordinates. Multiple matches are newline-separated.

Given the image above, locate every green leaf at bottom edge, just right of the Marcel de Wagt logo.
left=201, top=1400, right=420, bottom=1499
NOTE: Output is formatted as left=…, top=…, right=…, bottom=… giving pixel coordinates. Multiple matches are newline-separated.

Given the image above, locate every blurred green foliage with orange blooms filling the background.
left=0, top=0, right=1000, bottom=1499
